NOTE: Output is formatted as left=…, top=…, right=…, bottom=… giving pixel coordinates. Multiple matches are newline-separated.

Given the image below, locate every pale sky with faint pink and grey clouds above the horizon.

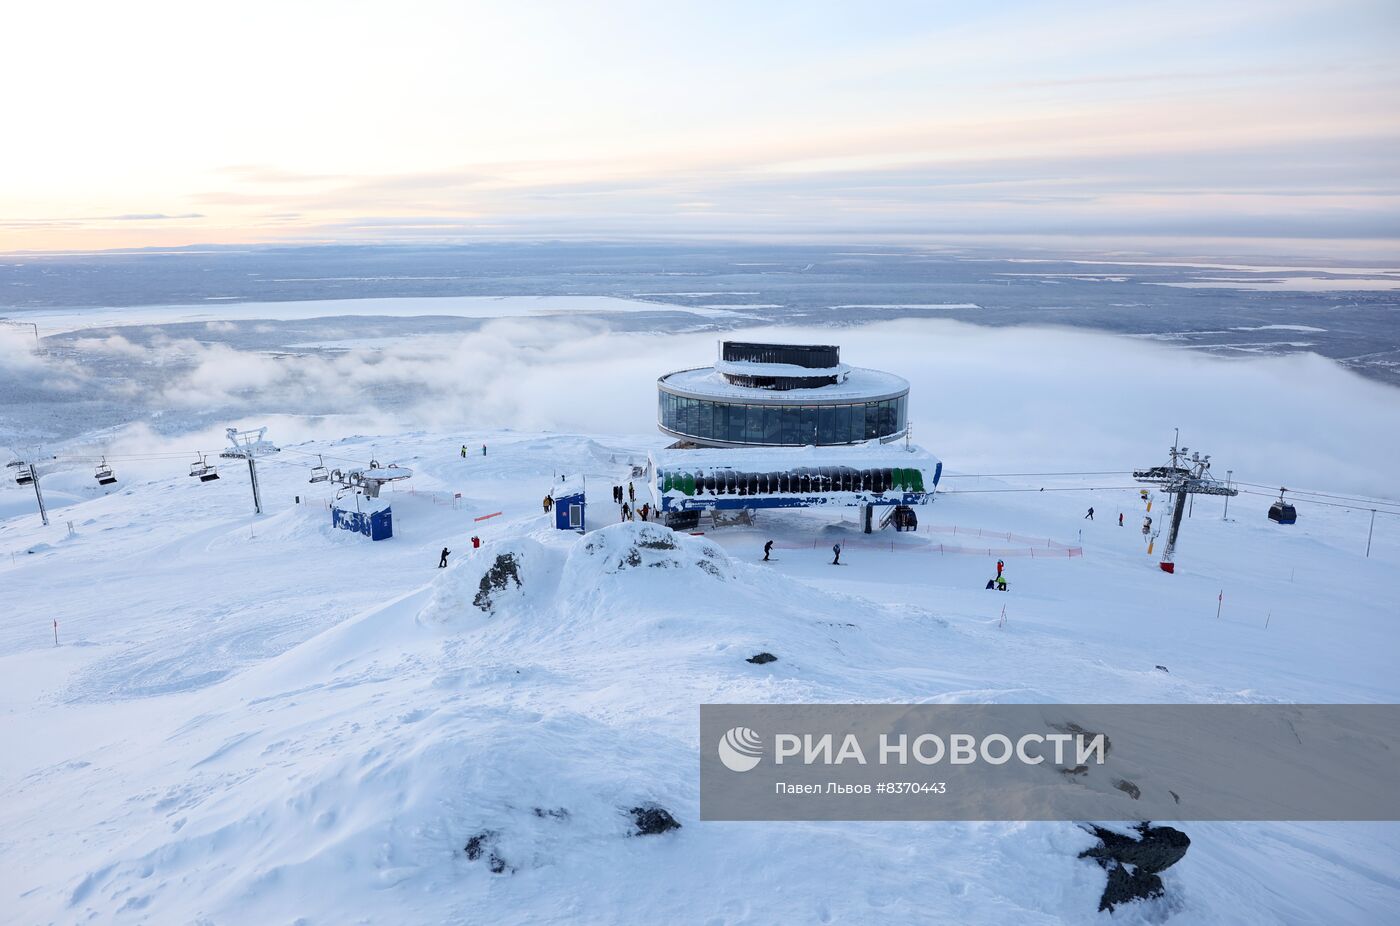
left=0, top=0, right=1400, bottom=251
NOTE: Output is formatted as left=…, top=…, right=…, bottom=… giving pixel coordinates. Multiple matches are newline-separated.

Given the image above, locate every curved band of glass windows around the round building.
left=657, top=389, right=909, bottom=447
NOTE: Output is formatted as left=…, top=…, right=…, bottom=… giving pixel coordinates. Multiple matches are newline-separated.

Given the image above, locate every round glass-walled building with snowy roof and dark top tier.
left=657, top=340, right=909, bottom=447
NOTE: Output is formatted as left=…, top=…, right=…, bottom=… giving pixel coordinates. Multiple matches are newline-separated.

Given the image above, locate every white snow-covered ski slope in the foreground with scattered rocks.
left=0, top=431, right=1400, bottom=925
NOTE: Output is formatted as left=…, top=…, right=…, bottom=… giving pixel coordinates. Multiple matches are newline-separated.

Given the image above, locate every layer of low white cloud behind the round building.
left=0, top=319, right=1400, bottom=504
